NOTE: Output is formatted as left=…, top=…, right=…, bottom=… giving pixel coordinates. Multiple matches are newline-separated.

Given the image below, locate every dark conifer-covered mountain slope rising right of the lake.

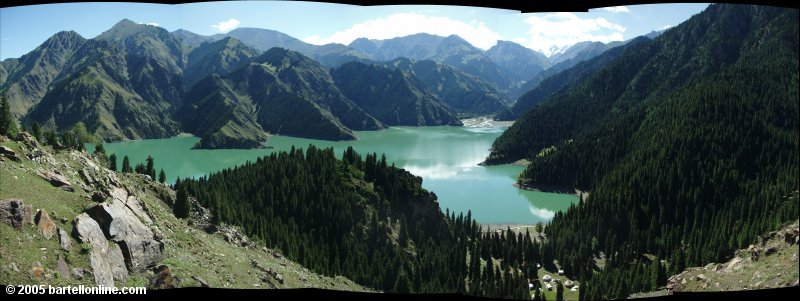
left=478, top=4, right=800, bottom=299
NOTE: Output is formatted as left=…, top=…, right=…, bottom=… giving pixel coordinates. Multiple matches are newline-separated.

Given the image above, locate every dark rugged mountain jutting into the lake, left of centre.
left=176, top=48, right=385, bottom=148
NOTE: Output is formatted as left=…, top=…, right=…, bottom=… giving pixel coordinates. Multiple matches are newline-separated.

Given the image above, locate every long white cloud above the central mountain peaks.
left=304, top=13, right=500, bottom=49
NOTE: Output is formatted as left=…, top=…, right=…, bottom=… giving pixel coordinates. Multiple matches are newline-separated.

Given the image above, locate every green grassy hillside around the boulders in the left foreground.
left=0, top=138, right=365, bottom=291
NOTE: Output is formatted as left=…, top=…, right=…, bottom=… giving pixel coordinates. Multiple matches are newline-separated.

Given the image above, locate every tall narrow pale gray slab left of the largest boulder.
left=73, top=212, right=114, bottom=287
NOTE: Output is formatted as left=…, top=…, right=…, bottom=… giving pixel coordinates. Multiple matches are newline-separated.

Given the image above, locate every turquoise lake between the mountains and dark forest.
left=94, top=126, right=578, bottom=224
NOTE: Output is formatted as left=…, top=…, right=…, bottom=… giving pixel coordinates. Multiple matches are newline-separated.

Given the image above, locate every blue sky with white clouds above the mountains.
left=0, top=1, right=708, bottom=60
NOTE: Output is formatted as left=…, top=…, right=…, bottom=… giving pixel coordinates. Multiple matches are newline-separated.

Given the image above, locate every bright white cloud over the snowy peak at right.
left=517, top=12, right=625, bottom=56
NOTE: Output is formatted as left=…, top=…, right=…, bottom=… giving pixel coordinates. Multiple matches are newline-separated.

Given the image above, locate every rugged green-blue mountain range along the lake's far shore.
left=0, top=19, right=664, bottom=148
